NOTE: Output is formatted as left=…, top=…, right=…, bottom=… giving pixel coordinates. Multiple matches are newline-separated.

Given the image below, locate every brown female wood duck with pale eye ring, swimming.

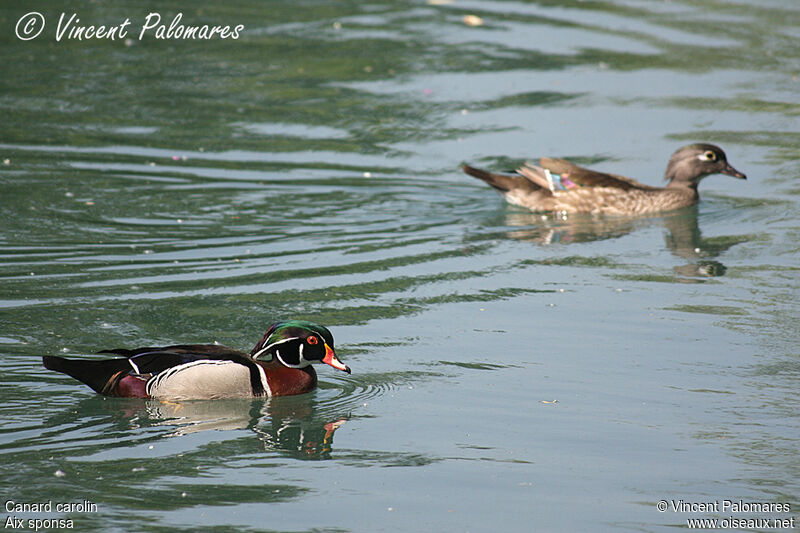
left=461, top=144, right=747, bottom=215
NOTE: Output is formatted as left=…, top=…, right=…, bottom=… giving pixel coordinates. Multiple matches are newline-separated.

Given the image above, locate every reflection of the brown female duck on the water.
left=496, top=205, right=748, bottom=278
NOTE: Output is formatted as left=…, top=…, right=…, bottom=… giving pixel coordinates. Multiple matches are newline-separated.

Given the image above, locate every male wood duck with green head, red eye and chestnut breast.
left=42, top=320, right=350, bottom=400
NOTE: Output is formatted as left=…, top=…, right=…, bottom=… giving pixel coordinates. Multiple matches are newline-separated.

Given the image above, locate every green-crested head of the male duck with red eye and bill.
left=250, top=320, right=350, bottom=374
